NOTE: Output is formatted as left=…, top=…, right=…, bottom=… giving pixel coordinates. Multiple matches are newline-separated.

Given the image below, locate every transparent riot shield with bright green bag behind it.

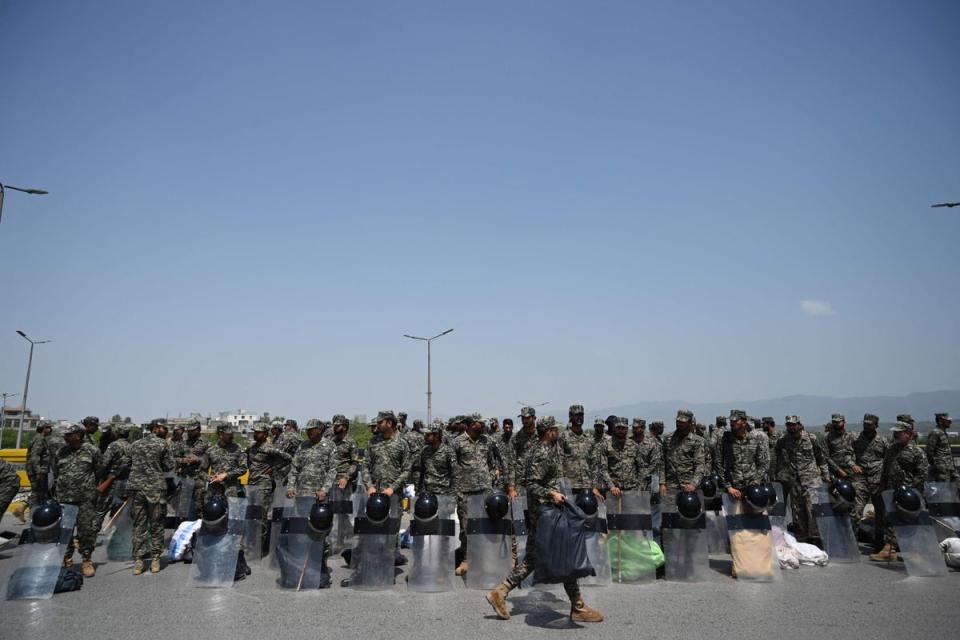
left=606, top=490, right=663, bottom=583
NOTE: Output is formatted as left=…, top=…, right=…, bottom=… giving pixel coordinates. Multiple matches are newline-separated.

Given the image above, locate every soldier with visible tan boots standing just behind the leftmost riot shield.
left=53, top=424, right=100, bottom=578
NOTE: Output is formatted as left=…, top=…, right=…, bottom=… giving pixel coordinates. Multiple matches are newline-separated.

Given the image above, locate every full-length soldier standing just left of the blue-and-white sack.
left=126, top=422, right=176, bottom=576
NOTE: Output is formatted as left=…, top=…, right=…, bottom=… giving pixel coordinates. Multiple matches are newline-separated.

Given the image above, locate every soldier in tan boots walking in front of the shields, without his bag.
left=487, top=417, right=603, bottom=622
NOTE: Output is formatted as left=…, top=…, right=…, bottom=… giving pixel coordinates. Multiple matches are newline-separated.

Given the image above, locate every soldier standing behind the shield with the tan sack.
left=719, top=409, right=770, bottom=500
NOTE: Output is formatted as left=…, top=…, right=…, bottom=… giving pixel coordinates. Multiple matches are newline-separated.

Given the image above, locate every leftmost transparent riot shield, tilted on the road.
left=7, top=504, right=79, bottom=600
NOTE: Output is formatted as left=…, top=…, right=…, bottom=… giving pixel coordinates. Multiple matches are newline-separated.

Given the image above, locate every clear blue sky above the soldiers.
left=0, top=0, right=960, bottom=419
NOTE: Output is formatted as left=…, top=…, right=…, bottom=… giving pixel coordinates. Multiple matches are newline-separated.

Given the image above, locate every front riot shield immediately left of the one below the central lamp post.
left=350, top=494, right=400, bottom=591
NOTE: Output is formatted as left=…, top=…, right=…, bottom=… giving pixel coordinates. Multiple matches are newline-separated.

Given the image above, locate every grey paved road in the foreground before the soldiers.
left=0, top=515, right=960, bottom=640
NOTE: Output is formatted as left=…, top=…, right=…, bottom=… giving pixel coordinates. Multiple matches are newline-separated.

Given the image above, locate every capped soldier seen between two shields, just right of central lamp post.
left=451, top=414, right=506, bottom=576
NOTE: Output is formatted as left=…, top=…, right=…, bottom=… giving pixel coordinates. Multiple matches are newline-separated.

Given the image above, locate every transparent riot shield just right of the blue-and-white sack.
left=189, top=498, right=246, bottom=587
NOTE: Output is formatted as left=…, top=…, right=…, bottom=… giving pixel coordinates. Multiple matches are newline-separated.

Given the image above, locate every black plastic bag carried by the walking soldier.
left=533, top=502, right=596, bottom=583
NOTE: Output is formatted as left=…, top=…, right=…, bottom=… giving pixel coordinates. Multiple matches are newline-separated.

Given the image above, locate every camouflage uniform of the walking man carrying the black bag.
left=504, top=439, right=580, bottom=604
